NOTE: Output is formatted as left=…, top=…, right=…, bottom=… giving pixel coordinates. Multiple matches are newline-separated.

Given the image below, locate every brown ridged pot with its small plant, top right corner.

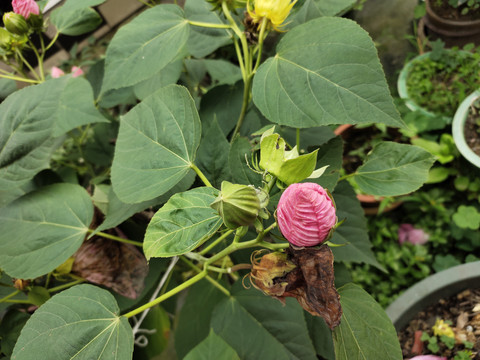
left=423, top=0, right=480, bottom=47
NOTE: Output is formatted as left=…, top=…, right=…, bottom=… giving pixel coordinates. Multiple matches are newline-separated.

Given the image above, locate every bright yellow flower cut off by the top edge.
left=248, top=0, right=297, bottom=31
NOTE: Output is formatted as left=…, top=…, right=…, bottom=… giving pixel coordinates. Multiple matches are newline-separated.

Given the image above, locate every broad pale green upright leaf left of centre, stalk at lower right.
left=112, top=85, right=201, bottom=203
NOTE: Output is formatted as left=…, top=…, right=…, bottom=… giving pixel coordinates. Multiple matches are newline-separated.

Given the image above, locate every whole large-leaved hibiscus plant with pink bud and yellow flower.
left=0, top=0, right=433, bottom=360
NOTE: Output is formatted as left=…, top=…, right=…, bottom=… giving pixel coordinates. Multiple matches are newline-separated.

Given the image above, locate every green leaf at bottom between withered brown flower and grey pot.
left=333, top=284, right=403, bottom=360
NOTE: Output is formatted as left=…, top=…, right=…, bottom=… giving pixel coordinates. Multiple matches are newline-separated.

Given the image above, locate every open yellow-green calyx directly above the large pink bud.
left=259, top=133, right=318, bottom=185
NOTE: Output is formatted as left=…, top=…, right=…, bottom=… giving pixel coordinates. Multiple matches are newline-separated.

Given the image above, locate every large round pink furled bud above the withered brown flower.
left=277, top=183, right=337, bottom=247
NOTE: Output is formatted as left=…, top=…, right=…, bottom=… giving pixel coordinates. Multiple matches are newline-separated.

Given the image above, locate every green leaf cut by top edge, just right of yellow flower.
left=287, top=0, right=357, bottom=29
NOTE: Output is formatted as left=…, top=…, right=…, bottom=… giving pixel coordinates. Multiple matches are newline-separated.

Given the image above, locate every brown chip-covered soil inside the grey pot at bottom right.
left=398, top=288, right=480, bottom=359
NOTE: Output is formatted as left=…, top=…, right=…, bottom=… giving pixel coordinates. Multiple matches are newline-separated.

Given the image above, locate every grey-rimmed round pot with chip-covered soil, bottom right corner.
left=386, top=261, right=480, bottom=359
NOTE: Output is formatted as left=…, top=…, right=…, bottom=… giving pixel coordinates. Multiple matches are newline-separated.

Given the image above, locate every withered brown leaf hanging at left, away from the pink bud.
left=72, top=237, right=148, bottom=299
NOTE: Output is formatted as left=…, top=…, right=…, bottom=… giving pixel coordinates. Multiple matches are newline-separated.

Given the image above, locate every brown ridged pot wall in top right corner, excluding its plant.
left=424, top=0, right=480, bottom=47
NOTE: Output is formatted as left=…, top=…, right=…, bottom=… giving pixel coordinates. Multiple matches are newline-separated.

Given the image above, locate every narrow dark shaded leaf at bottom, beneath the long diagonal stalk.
left=175, top=280, right=230, bottom=359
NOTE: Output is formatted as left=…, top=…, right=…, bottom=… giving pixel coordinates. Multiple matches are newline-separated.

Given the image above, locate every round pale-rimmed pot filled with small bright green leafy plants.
left=397, top=42, right=480, bottom=129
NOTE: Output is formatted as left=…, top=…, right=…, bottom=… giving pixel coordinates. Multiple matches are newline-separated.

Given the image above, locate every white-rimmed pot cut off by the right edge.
left=452, top=91, right=480, bottom=167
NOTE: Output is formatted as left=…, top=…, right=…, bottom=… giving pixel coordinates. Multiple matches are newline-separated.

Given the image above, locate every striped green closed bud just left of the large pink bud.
left=210, top=181, right=261, bottom=229
